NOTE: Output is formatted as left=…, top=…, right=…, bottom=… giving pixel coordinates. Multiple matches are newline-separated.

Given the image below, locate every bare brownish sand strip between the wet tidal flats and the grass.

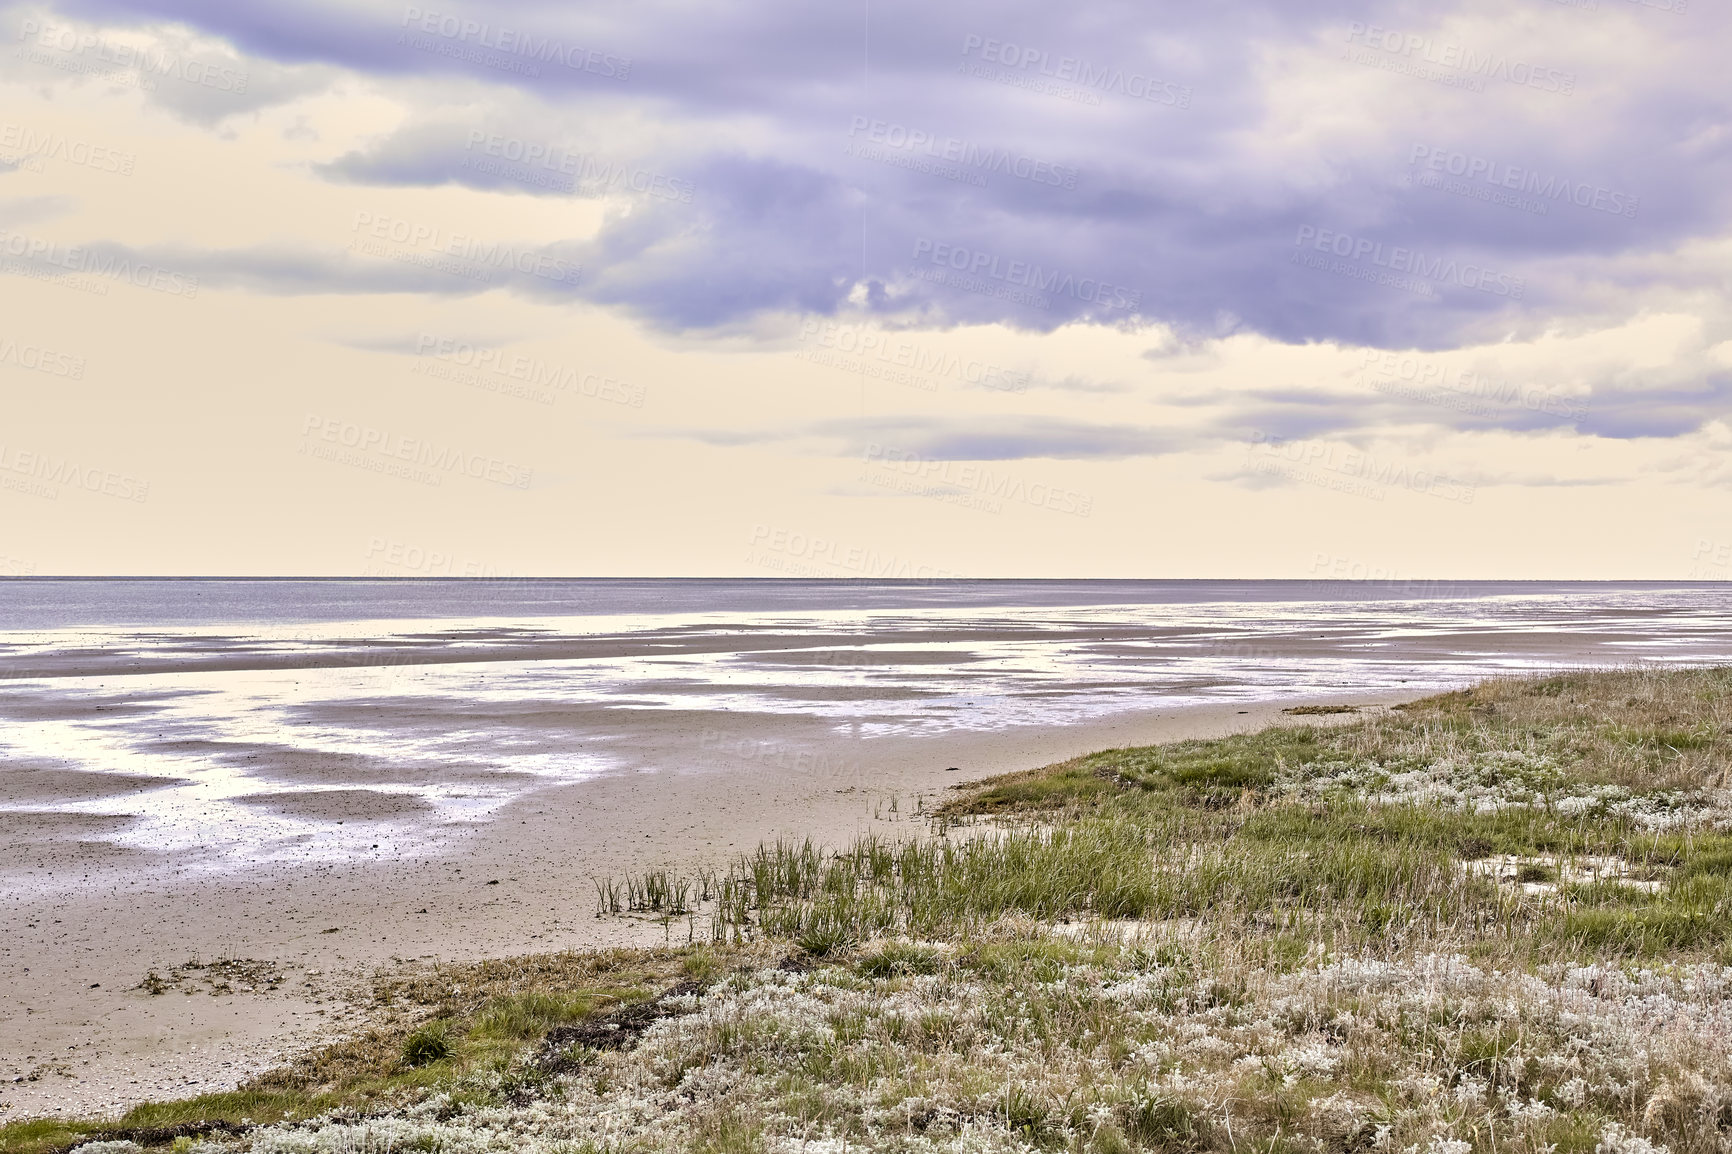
left=0, top=695, right=1412, bottom=1119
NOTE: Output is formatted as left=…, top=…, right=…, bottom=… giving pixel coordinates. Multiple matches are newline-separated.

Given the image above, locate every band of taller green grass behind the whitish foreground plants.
left=633, top=669, right=1732, bottom=956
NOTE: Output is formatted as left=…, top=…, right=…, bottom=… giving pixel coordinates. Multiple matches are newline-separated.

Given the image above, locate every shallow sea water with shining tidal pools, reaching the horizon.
left=0, top=577, right=1732, bottom=870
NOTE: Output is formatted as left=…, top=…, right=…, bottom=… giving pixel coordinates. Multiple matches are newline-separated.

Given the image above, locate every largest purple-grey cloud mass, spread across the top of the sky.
left=33, top=0, right=1732, bottom=360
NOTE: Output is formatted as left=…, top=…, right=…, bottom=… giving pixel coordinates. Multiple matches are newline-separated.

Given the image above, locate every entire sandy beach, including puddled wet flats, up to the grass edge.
left=0, top=587, right=1732, bottom=1118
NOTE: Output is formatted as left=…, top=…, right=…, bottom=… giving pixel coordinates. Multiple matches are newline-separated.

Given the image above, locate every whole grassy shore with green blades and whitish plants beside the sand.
left=5, top=669, right=1732, bottom=1154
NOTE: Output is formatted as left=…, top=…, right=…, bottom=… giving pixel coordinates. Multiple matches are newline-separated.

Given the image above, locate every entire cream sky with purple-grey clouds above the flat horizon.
left=0, top=0, right=1732, bottom=580
